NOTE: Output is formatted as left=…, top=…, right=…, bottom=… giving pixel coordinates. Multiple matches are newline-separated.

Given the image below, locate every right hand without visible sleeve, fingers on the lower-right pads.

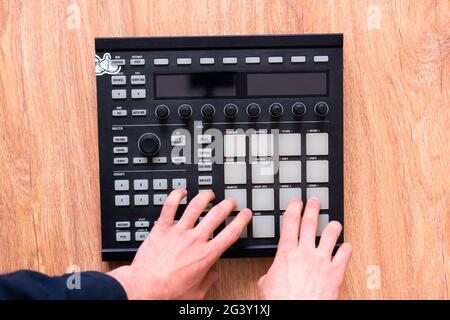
left=258, top=198, right=352, bottom=299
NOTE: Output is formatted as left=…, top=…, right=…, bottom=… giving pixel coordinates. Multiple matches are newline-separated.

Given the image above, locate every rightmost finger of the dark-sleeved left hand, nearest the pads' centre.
left=208, top=209, right=252, bottom=259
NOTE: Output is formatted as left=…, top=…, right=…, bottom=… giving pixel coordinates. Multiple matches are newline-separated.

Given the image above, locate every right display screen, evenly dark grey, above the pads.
left=247, top=72, right=328, bottom=96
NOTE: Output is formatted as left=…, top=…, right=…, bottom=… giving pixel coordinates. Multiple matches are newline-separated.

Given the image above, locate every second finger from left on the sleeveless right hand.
left=299, top=197, right=320, bottom=248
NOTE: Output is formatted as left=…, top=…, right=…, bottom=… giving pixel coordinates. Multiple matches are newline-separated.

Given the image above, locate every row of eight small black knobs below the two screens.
left=155, top=102, right=329, bottom=119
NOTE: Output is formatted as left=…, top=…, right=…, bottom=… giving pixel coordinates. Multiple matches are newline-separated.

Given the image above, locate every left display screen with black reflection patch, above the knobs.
left=155, top=72, right=237, bottom=98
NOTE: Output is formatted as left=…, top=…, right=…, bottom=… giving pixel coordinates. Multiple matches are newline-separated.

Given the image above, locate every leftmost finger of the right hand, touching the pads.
left=277, top=200, right=303, bottom=252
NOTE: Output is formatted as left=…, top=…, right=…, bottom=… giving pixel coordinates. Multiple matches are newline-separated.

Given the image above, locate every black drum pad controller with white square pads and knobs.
left=96, top=34, right=344, bottom=260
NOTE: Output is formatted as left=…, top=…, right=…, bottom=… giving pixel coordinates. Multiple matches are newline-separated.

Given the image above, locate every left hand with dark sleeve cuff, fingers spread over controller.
left=109, top=189, right=252, bottom=299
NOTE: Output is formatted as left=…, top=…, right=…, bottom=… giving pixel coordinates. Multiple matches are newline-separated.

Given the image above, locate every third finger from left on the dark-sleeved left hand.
left=195, top=199, right=236, bottom=239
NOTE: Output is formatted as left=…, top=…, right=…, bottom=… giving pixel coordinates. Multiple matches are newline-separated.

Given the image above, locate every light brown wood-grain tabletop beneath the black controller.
left=0, top=0, right=450, bottom=299
